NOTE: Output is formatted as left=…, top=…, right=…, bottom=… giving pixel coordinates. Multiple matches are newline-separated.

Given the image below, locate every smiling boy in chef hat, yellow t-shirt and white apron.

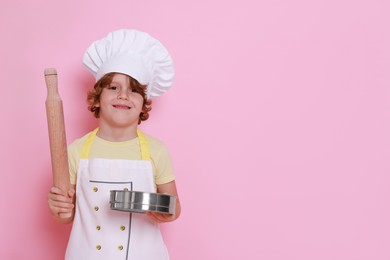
left=48, top=29, right=181, bottom=260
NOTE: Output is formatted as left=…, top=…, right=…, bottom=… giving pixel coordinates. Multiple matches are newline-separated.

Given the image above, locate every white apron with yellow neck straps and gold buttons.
left=65, top=129, right=169, bottom=260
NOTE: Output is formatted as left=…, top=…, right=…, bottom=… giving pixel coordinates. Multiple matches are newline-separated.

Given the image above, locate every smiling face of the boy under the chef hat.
left=98, top=73, right=143, bottom=127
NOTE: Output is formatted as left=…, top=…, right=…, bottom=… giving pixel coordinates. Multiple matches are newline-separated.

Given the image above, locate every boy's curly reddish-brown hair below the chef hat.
left=87, top=72, right=152, bottom=124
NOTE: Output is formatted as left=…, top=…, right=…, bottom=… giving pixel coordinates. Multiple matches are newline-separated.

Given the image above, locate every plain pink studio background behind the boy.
left=0, top=0, right=390, bottom=260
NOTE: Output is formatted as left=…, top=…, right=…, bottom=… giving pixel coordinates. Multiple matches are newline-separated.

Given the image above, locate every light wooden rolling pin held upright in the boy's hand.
left=45, top=68, right=70, bottom=196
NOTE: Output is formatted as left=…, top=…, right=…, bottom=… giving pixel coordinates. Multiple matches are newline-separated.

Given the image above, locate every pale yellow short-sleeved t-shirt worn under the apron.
left=68, top=133, right=175, bottom=185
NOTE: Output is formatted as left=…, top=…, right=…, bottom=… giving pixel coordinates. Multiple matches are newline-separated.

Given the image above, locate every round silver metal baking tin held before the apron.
left=110, top=189, right=176, bottom=214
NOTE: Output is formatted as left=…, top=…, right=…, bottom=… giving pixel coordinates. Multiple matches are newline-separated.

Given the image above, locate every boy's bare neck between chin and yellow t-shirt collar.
left=96, top=125, right=137, bottom=142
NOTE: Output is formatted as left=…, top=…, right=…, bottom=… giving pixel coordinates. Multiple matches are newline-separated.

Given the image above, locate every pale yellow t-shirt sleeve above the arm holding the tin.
left=152, top=142, right=175, bottom=185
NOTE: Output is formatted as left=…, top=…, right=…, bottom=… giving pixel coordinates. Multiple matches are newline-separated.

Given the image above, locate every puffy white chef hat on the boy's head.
left=83, top=29, right=175, bottom=98
